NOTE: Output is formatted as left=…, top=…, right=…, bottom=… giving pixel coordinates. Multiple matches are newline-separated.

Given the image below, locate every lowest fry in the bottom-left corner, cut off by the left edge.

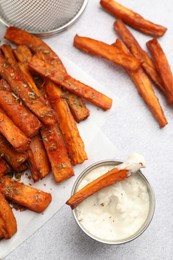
left=0, top=193, right=17, bottom=239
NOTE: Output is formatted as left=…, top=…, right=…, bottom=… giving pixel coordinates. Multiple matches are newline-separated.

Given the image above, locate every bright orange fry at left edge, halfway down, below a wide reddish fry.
left=0, top=110, right=30, bottom=152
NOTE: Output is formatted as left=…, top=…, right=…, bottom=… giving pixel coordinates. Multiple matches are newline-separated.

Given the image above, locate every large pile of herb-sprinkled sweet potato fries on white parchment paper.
left=0, top=27, right=112, bottom=239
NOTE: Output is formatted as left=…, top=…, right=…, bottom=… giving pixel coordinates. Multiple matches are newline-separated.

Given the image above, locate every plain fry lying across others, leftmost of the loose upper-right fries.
left=74, top=35, right=141, bottom=71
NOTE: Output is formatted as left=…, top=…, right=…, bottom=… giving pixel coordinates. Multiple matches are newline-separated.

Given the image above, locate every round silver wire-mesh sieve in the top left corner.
left=0, top=0, right=87, bottom=37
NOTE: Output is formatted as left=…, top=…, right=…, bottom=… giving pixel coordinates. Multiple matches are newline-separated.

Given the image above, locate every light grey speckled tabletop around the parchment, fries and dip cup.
left=4, top=0, right=173, bottom=260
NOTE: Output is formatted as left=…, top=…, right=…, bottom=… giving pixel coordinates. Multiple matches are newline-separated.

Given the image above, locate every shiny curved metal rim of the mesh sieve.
left=0, top=0, right=88, bottom=38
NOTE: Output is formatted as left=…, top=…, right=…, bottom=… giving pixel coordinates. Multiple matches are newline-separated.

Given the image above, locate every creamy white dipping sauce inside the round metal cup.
left=75, top=162, right=149, bottom=241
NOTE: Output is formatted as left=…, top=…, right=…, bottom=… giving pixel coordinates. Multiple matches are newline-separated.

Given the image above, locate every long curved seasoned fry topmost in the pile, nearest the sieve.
left=4, top=27, right=66, bottom=73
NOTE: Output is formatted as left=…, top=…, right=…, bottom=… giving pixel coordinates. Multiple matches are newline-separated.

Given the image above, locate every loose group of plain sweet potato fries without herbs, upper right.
left=74, top=0, right=173, bottom=127
